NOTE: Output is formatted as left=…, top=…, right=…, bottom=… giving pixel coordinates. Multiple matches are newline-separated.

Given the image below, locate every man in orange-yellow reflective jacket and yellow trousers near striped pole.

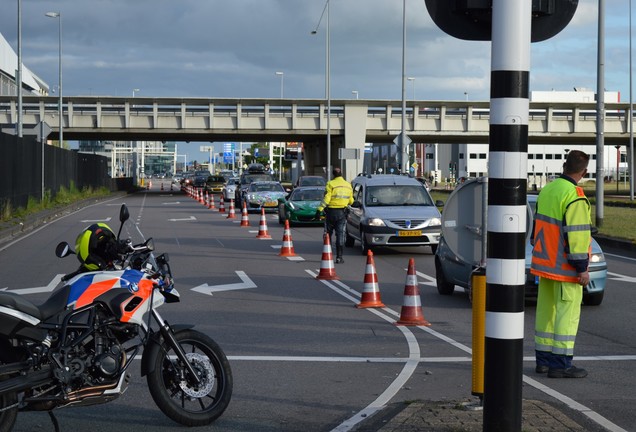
left=530, top=150, right=592, bottom=378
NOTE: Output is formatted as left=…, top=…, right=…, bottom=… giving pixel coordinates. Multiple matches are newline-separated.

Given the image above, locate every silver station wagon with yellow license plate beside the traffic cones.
left=345, top=174, right=444, bottom=255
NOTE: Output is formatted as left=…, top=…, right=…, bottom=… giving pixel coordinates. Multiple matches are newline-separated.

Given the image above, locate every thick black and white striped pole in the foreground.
left=484, top=0, right=532, bottom=431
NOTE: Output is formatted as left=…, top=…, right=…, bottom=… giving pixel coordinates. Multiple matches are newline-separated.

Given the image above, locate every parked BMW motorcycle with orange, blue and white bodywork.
left=0, top=204, right=233, bottom=432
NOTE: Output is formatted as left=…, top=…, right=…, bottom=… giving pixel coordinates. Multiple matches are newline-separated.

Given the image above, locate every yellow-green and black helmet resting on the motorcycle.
left=75, top=223, right=117, bottom=271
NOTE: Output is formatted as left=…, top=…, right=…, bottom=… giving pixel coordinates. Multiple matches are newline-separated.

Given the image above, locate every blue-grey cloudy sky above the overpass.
left=0, top=0, right=631, bottom=158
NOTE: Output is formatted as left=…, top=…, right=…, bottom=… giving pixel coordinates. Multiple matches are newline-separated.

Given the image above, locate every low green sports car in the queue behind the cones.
left=278, top=186, right=325, bottom=225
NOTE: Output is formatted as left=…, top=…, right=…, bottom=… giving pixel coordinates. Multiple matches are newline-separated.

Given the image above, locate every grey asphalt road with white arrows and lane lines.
left=0, top=185, right=636, bottom=432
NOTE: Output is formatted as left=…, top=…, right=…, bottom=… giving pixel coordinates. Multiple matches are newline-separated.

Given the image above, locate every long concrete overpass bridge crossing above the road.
left=0, top=96, right=633, bottom=176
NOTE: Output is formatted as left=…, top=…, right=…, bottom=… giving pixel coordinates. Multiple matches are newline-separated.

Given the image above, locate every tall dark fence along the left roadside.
left=0, top=133, right=110, bottom=213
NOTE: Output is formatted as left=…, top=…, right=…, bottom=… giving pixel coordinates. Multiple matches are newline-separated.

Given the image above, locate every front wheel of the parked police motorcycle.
left=147, top=330, right=233, bottom=426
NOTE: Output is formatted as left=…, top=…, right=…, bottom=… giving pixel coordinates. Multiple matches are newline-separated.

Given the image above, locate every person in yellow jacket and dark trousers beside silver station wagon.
left=316, top=167, right=353, bottom=264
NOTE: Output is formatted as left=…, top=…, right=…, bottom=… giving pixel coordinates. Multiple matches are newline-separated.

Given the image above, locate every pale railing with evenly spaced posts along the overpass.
left=0, top=96, right=630, bottom=141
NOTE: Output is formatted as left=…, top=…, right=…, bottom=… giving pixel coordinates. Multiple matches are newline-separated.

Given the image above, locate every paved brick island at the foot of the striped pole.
left=353, top=400, right=603, bottom=432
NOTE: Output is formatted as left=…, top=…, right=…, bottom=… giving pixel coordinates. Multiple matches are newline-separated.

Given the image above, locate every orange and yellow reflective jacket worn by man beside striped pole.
left=530, top=175, right=592, bottom=282
